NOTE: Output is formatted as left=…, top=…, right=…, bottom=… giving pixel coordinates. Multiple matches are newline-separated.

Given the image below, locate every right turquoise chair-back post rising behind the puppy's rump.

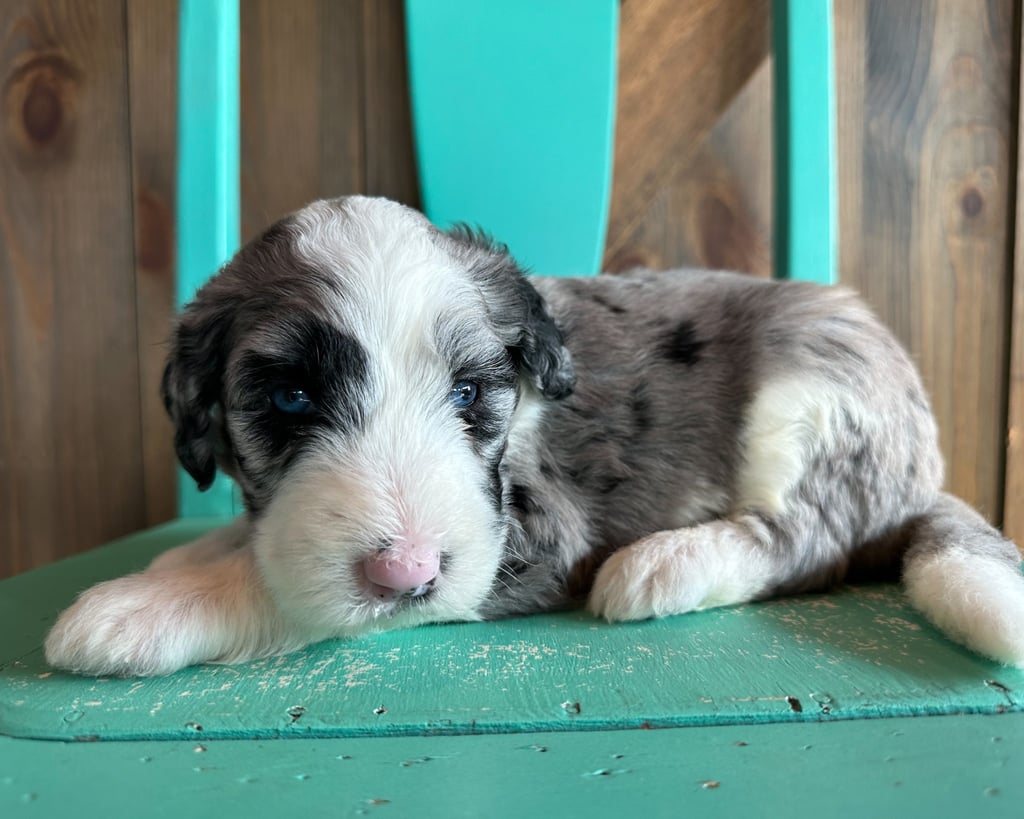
left=772, top=0, right=839, bottom=285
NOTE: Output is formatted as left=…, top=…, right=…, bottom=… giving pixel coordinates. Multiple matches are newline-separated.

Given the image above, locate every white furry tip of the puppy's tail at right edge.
left=903, top=547, right=1024, bottom=669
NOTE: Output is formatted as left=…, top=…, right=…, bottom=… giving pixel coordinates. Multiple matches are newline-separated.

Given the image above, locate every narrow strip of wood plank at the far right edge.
left=1002, top=12, right=1024, bottom=554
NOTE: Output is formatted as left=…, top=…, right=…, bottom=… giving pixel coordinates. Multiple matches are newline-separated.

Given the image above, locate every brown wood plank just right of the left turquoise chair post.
left=241, top=0, right=366, bottom=241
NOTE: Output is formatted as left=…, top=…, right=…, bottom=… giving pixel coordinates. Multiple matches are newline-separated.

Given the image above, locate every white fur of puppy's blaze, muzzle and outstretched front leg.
left=46, top=200, right=507, bottom=675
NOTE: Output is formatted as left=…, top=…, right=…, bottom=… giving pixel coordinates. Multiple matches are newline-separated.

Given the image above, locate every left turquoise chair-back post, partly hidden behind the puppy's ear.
left=176, top=0, right=240, bottom=517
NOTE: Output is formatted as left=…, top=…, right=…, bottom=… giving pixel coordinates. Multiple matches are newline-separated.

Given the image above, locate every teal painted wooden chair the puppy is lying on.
left=0, top=0, right=1024, bottom=817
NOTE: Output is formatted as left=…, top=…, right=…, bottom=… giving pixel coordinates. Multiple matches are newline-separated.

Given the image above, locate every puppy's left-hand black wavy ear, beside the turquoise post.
left=161, top=300, right=230, bottom=490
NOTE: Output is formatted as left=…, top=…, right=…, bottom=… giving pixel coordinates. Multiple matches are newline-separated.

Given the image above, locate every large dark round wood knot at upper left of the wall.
left=4, top=53, right=79, bottom=160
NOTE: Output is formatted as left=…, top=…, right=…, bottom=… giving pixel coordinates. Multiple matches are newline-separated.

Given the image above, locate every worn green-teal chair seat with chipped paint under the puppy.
left=0, top=519, right=1024, bottom=817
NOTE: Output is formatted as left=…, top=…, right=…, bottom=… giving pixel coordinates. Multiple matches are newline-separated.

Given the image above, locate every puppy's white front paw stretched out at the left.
left=45, top=573, right=215, bottom=677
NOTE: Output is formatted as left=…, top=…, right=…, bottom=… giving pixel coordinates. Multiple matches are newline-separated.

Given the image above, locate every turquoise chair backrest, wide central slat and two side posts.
left=177, top=0, right=837, bottom=517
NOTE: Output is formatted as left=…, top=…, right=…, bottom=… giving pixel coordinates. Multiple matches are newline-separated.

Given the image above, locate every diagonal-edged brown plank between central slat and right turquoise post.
left=606, top=0, right=770, bottom=256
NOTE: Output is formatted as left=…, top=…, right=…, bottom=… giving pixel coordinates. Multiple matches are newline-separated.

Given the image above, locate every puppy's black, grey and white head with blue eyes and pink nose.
left=164, top=198, right=574, bottom=637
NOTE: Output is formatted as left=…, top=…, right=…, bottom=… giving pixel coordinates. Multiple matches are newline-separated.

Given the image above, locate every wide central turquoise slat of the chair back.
left=406, top=0, right=618, bottom=274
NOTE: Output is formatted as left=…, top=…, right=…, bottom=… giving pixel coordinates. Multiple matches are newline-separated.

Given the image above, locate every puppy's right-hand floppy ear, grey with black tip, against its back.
left=444, top=225, right=575, bottom=399
